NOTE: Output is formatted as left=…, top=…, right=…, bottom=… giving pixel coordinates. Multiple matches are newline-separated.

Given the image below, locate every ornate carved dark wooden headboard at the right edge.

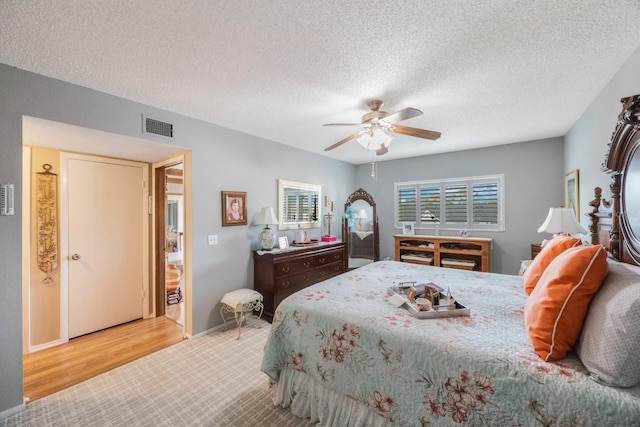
left=591, top=95, right=640, bottom=264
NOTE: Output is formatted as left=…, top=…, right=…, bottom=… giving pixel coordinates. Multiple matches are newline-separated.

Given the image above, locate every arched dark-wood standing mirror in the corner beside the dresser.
left=342, top=188, right=380, bottom=269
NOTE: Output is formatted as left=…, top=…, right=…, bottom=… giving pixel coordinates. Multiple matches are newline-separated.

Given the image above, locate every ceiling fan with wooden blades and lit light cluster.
left=324, top=99, right=440, bottom=156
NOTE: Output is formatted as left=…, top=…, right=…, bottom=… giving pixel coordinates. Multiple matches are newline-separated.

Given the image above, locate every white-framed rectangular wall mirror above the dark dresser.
left=278, top=179, right=322, bottom=230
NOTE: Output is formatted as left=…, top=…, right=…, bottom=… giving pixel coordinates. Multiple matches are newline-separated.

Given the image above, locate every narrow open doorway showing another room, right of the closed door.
left=154, top=158, right=186, bottom=326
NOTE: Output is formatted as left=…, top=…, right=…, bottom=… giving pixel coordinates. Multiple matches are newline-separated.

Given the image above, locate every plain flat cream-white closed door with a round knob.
left=66, top=156, right=148, bottom=338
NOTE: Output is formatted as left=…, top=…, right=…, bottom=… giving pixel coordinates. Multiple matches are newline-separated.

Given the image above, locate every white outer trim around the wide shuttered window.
left=393, top=174, right=505, bottom=232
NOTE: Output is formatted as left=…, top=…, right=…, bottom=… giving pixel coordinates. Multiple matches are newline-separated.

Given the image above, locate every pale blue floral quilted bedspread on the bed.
left=261, top=261, right=640, bottom=426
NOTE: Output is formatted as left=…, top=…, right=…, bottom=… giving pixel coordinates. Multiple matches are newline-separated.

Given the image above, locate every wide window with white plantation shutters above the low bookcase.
left=395, top=175, right=504, bottom=231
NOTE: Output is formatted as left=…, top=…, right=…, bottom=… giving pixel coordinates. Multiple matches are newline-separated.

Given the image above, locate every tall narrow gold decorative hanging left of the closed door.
left=36, top=163, right=58, bottom=283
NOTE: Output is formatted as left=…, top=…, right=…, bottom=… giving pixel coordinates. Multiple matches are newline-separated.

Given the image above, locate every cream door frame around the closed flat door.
left=59, top=151, right=153, bottom=343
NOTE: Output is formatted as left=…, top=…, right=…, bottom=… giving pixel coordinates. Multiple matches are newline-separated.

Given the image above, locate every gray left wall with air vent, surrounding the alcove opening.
left=0, top=64, right=356, bottom=414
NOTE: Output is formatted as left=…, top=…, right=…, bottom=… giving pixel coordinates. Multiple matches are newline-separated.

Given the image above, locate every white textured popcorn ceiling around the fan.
left=0, top=0, right=640, bottom=164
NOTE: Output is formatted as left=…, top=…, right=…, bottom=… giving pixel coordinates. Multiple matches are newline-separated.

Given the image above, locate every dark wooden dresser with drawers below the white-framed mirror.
left=253, top=242, right=346, bottom=321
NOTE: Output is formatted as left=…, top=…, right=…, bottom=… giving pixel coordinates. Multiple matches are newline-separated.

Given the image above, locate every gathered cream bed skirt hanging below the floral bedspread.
left=272, top=368, right=394, bottom=427
